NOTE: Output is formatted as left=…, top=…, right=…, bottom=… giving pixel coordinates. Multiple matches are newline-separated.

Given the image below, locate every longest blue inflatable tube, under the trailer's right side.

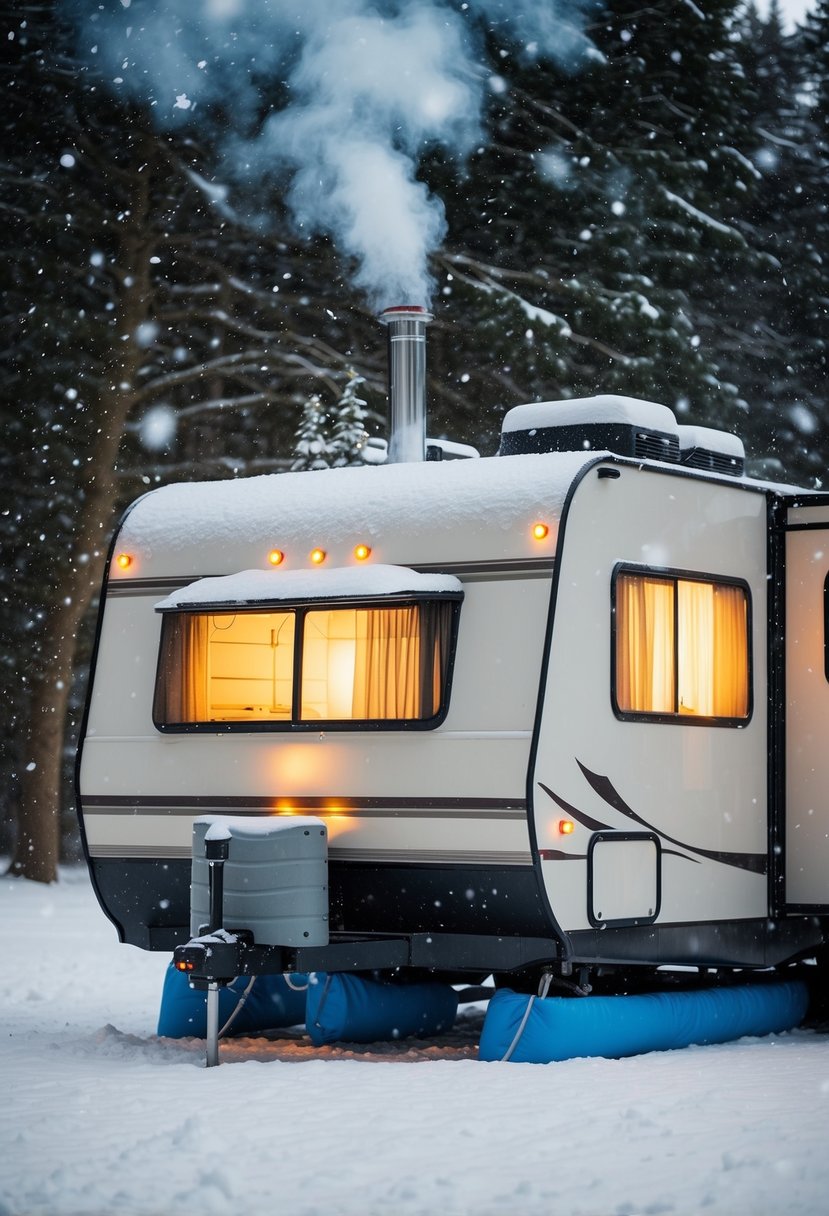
left=479, top=981, right=808, bottom=1064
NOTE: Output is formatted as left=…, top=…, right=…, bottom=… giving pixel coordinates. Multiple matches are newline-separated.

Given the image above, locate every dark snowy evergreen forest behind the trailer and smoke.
left=0, top=0, right=829, bottom=882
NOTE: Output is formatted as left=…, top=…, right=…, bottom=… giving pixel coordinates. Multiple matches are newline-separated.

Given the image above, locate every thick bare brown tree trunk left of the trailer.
left=9, top=139, right=154, bottom=883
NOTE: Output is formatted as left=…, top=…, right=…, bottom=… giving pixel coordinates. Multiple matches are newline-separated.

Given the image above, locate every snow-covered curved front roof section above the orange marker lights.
left=111, top=451, right=597, bottom=582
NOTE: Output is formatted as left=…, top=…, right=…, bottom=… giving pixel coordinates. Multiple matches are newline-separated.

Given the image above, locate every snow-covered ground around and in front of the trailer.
left=0, top=869, right=829, bottom=1216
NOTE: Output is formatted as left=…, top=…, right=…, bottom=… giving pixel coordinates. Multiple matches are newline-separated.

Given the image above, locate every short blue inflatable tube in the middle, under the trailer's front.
left=305, top=973, right=458, bottom=1047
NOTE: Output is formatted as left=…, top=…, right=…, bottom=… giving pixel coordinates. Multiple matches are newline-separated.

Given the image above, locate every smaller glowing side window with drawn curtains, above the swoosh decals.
left=613, top=567, right=751, bottom=725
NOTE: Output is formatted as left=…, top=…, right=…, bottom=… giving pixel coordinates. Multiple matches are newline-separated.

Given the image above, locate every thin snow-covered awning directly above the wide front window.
left=156, top=565, right=463, bottom=612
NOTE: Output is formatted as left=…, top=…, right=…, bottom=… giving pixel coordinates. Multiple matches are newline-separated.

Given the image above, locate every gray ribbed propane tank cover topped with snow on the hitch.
left=190, top=815, right=328, bottom=946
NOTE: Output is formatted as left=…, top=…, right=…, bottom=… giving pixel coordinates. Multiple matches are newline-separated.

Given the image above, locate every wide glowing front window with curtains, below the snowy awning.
left=153, top=596, right=461, bottom=730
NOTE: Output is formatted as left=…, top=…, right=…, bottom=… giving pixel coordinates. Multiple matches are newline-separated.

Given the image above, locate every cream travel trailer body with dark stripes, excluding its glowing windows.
left=78, top=399, right=829, bottom=970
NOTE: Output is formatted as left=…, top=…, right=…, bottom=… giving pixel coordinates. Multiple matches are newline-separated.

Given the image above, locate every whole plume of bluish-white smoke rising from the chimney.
left=74, top=0, right=594, bottom=308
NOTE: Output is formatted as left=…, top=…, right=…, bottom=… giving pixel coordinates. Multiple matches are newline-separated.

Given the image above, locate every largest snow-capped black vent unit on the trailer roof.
left=498, top=395, right=679, bottom=465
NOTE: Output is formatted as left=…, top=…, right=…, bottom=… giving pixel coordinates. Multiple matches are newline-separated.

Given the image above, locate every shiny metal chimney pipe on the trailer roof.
left=379, top=305, right=432, bottom=465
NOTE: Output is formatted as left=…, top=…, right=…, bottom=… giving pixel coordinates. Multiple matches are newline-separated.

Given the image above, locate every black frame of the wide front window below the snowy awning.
left=152, top=591, right=463, bottom=734
